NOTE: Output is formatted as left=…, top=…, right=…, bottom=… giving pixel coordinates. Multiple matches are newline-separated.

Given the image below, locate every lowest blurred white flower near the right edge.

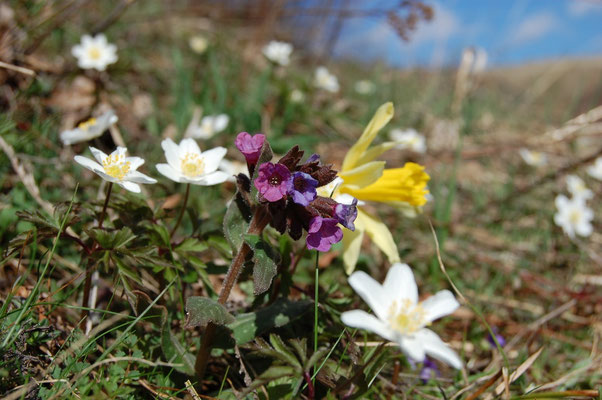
left=554, top=194, right=594, bottom=239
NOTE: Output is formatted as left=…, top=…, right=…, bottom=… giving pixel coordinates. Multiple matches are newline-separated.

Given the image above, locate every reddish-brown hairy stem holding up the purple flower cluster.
left=194, top=206, right=270, bottom=382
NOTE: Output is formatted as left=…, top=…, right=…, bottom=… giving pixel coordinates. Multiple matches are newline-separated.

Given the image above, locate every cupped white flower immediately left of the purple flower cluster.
left=157, top=139, right=228, bottom=186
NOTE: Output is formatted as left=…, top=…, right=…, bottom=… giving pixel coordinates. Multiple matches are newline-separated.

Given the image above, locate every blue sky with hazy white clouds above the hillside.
left=335, top=0, right=602, bottom=66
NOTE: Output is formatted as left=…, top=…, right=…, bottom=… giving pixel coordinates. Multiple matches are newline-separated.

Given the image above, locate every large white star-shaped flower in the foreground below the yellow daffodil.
left=341, top=263, right=462, bottom=368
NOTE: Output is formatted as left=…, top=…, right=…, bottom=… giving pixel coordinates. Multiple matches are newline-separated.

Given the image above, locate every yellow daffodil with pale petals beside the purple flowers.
left=333, top=102, right=430, bottom=274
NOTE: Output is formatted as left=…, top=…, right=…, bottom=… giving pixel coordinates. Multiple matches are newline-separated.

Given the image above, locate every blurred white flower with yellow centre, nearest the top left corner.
left=71, top=33, right=117, bottom=71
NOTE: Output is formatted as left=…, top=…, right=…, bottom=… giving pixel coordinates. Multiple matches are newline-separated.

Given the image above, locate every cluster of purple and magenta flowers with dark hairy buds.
left=236, top=132, right=357, bottom=251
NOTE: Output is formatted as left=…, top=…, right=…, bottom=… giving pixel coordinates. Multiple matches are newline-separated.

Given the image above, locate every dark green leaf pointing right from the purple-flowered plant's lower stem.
left=228, top=299, right=312, bottom=345
